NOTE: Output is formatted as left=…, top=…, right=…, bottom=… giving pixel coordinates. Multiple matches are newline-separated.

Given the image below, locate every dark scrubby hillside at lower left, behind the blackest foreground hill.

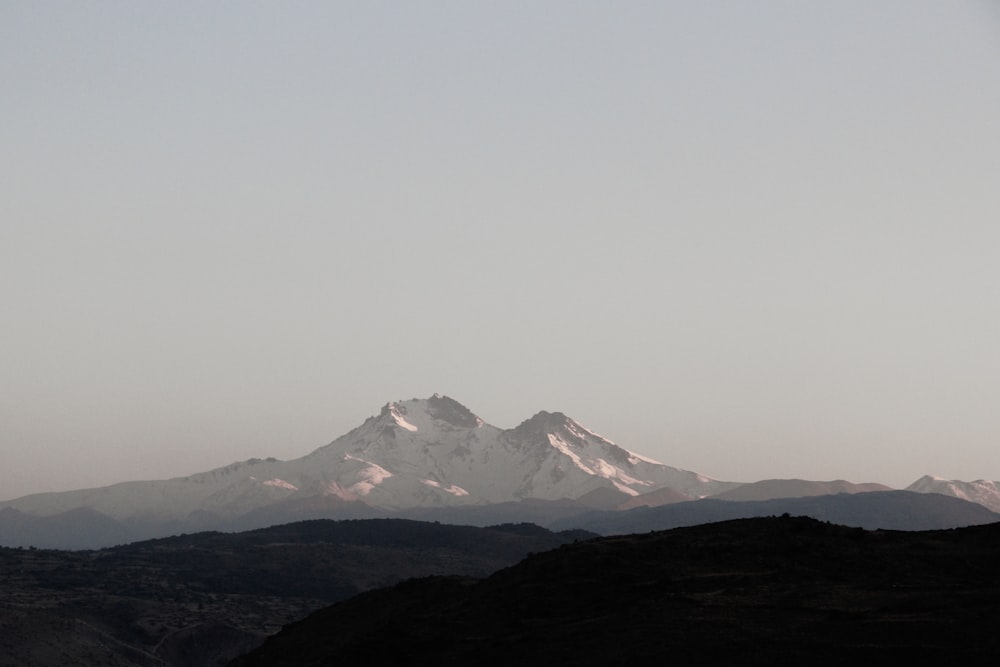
left=0, top=519, right=593, bottom=667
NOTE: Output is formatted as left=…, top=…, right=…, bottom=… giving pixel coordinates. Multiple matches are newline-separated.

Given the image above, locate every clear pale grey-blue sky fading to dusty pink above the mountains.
left=0, top=0, right=1000, bottom=499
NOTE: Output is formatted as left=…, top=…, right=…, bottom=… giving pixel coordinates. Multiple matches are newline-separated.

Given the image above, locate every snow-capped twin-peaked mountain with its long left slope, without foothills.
left=0, top=394, right=738, bottom=523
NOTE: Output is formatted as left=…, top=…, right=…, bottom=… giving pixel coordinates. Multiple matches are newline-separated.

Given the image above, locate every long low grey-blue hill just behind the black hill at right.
left=548, top=491, right=1000, bottom=535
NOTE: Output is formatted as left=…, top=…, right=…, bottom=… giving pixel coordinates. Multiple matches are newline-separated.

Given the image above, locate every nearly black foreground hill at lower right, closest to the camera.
left=231, top=517, right=1000, bottom=667
